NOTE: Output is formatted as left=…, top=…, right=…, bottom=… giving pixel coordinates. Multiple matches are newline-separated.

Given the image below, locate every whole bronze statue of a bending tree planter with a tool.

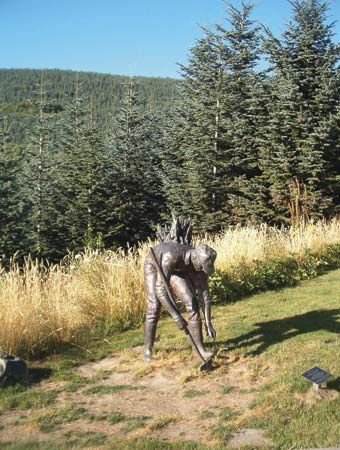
left=144, top=217, right=216, bottom=368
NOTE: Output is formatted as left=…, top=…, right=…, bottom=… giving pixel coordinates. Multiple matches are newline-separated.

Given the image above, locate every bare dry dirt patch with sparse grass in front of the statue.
left=0, top=348, right=271, bottom=448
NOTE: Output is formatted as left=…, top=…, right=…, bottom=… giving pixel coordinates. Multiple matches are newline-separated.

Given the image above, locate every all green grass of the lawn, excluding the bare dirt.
left=0, top=270, right=340, bottom=450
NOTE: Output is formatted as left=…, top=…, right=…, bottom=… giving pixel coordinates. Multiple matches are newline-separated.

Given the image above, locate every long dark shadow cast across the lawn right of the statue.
left=217, top=309, right=340, bottom=356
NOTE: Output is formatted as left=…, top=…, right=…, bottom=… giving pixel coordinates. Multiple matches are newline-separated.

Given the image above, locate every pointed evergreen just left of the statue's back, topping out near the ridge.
left=105, top=78, right=164, bottom=246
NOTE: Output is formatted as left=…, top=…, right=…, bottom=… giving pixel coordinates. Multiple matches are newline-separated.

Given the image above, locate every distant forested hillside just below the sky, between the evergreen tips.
left=0, top=69, right=178, bottom=117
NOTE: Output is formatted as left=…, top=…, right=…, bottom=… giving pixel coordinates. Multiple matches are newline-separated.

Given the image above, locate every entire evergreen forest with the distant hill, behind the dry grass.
left=0, top=0, right=340, bottom=263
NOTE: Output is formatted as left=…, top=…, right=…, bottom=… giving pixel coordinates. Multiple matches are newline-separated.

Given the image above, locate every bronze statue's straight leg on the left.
left=144, top=261, right=161, bottom=361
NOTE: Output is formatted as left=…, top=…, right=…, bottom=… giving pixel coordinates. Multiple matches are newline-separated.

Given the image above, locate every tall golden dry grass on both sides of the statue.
left=0, top=220, right=340, bottom=356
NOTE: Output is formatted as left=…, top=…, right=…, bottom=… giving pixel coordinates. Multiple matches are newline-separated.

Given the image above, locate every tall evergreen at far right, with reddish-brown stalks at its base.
left=260, top=0, right=339, bottom=222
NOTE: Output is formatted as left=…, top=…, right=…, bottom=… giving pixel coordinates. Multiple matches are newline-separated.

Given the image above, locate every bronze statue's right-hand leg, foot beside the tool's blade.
left=170, top=274, right=213, bottom=360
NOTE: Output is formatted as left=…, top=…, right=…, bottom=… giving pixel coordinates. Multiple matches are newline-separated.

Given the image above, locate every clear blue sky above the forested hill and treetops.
left=0, top=0, right=340, bottom=77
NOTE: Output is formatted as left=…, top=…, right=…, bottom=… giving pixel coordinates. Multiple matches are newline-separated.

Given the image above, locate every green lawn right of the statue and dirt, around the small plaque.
left=215, top=271, right=340, bottom=449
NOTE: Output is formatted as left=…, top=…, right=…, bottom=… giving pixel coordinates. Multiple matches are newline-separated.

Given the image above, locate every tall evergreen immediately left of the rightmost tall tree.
left=217, top=2, right=266, bottom=223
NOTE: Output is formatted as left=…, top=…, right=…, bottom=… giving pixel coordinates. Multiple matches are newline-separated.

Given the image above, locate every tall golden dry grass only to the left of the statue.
left=0, top=246, right=147, bottom=356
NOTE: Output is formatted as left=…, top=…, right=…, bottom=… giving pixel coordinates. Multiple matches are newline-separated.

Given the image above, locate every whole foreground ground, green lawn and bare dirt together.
left=0, top=270, right=340, bottom=450
